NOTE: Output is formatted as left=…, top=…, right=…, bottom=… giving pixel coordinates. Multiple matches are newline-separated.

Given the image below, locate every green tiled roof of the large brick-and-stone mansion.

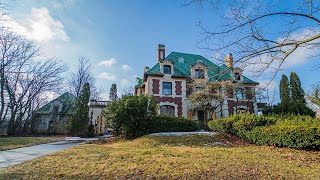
left=139, top=52, right=259, bottom=84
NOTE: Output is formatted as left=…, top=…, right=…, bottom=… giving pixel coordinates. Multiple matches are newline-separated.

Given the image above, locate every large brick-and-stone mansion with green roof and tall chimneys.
left=135, top=44, right=259, bottom=120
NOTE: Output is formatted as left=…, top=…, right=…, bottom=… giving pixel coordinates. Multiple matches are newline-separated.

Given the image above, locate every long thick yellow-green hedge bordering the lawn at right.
left=208, top=115, right=320, bottom=150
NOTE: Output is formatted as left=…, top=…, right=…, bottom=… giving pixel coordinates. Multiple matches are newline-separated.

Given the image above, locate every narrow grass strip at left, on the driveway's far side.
left=0, top=136, right=63, bottom=151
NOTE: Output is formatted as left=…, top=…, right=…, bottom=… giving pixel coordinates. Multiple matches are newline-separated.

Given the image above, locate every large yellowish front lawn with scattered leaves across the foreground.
left=0, top=134, right=320, bottom=179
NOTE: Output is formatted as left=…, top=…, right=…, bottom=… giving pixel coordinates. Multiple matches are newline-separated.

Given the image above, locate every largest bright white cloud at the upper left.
left=1, top=7, right=70, bottom=42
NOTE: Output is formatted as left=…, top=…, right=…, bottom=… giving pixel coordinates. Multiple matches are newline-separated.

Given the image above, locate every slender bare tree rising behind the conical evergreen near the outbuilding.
left=68, top=57, right=100, bottom=99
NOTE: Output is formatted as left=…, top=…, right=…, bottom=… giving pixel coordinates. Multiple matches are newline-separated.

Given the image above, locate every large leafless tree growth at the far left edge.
left=0, top=29, right=66, bottom=135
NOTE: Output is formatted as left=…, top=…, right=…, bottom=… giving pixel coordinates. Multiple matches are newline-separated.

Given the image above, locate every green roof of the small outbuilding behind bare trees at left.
left=35, top=92, right=76, bottom=114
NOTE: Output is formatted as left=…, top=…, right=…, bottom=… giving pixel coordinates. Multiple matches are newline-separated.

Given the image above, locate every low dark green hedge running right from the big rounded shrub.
left=148, top=115, right=199, bottom=133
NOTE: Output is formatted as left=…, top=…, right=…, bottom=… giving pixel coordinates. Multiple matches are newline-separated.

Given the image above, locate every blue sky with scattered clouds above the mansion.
left=6, top=0, right=320, bottom=102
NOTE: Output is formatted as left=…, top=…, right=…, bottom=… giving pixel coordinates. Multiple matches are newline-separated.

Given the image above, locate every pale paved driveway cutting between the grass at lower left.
left=0, top=141, right=82, bottom=169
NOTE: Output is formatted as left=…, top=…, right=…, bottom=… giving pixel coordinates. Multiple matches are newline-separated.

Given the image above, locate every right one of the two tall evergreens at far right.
left=290, top=72, right=306, bottom=103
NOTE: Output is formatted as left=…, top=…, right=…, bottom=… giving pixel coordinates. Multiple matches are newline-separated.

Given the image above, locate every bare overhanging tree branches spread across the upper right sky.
left=184, top=0, right=320, bottom=78
